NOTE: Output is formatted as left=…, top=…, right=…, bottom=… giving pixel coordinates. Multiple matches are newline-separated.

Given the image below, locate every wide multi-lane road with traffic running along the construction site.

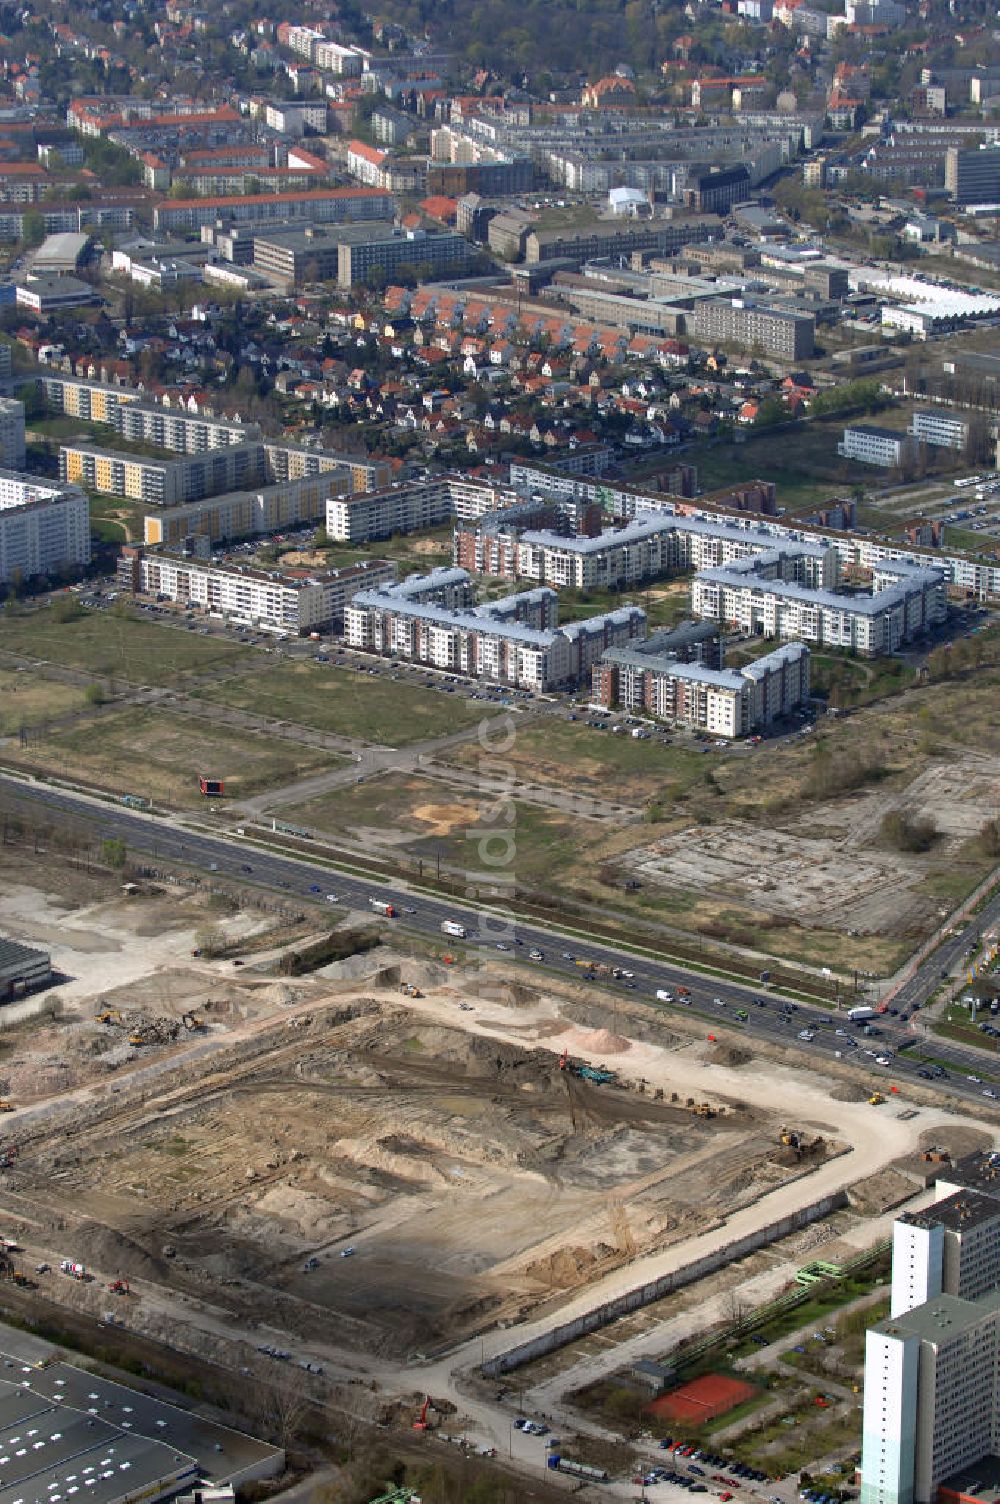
left=0, top=775, right=1000, bottom=1105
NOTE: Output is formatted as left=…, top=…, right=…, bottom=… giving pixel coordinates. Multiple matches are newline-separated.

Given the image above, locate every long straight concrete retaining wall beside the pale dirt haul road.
left=483, top=1191, right=847, bottom=1378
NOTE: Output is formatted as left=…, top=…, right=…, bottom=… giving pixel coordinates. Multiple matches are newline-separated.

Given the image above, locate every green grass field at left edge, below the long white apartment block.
left=0, top=608, right=251, bottom=684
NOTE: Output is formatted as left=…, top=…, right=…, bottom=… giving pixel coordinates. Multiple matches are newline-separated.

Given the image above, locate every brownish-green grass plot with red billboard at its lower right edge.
left=10, top=707, right=331, bottom=809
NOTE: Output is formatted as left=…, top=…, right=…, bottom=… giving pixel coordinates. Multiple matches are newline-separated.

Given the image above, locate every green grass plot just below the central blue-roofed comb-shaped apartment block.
left=190, top=663, right=495, bottom=746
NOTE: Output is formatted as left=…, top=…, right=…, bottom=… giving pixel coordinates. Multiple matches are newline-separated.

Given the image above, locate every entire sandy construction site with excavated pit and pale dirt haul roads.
left=0, top=847, right=992, bottom=1504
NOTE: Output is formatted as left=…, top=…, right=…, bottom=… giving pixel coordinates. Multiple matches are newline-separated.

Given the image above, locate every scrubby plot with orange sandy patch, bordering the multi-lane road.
left=286, top=775, right=605, bottom=886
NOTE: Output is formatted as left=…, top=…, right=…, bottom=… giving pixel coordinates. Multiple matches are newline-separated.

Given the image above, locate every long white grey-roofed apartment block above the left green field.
left=138, top=553, right=395, bottom=636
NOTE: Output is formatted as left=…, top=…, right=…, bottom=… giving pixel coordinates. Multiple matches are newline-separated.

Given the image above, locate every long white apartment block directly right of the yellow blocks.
left=326, top=474, right=510, bottom=543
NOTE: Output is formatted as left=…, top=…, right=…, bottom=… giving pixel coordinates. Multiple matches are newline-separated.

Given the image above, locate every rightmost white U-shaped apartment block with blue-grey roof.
left=692, top=549, right=947, bottom=657
